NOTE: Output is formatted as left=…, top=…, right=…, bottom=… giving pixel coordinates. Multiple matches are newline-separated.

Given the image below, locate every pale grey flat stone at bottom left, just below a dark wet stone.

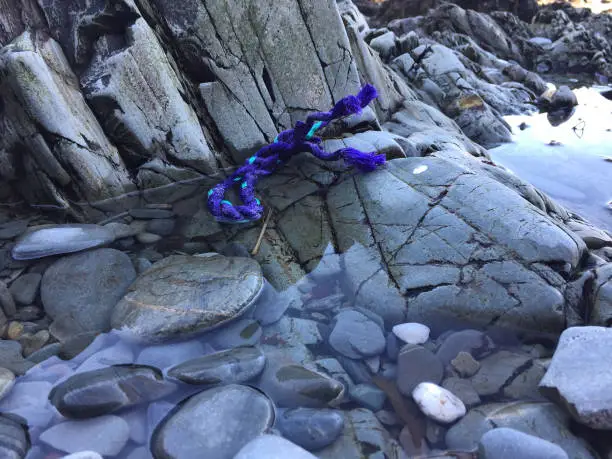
left=40, top=415, right=130, bottom=456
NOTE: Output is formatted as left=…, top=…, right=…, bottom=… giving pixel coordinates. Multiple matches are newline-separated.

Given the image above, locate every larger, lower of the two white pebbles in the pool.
left=412, top=382, right=465, bottom=424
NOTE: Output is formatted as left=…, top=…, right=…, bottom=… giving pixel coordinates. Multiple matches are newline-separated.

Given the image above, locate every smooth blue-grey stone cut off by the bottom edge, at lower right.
left=478, top=427, right=569, bottom=459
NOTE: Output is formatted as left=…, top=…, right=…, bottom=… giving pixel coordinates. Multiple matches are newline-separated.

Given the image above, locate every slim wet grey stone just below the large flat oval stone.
left=168, top=347, right=266, bottom=385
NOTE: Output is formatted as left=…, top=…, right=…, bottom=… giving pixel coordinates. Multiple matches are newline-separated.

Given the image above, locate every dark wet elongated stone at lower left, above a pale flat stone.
left=49, top=365, right=175, bottom=419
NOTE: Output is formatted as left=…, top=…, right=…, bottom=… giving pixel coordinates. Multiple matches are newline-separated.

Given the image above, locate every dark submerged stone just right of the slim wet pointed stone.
left=259, top=360, right=344, bottom=408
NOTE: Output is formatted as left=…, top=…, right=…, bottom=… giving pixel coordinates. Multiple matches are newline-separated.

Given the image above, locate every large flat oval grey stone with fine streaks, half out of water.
left=112, top=254, right=263, bottom=341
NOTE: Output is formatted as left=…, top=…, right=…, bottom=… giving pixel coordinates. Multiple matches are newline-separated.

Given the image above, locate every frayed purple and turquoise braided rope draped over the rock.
left=208, top=84, right=385, bottom=223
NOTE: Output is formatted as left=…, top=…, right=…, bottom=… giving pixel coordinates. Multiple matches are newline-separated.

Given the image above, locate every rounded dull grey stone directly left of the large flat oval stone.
left=40, top=249, right=136, bottom=335
